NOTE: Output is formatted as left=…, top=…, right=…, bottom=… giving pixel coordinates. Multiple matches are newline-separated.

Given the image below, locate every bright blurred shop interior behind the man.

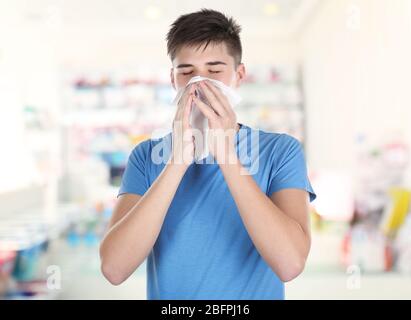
left=0, top=0, right=411, bottom=299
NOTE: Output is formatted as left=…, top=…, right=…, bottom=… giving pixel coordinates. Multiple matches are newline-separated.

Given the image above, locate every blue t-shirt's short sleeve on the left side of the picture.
left=117, top=140, right=150, bottom=197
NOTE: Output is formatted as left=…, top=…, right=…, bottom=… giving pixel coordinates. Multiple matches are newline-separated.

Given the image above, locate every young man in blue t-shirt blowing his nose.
left=100, top=9, right=316, bottom=299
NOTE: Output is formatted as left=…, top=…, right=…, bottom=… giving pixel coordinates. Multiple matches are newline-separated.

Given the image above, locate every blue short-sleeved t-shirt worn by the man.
left=119, top=124, right=316, bottom=300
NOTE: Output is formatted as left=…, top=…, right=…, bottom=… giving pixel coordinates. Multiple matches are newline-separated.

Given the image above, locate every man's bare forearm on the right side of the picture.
left=220, top=159, right=310, bottom=281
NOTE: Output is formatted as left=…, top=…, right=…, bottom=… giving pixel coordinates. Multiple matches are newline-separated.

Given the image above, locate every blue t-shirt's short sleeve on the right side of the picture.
left=268, top=134, right=317, bottom=202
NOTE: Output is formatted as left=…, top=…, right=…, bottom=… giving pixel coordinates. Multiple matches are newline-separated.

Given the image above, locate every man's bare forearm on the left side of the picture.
left=100, top=164, right=187, bottom=284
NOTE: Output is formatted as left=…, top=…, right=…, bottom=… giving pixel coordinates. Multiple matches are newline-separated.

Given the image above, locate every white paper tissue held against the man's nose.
left=173, top=76, right=241, bottom=161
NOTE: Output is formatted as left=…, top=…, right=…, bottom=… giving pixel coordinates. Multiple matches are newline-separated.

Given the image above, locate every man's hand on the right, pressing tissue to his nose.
left=193, top=80, right=238, bottom=164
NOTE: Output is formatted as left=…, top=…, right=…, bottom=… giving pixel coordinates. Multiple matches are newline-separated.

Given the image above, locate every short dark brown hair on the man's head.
left=166, top=9, right=242, bottom=66
